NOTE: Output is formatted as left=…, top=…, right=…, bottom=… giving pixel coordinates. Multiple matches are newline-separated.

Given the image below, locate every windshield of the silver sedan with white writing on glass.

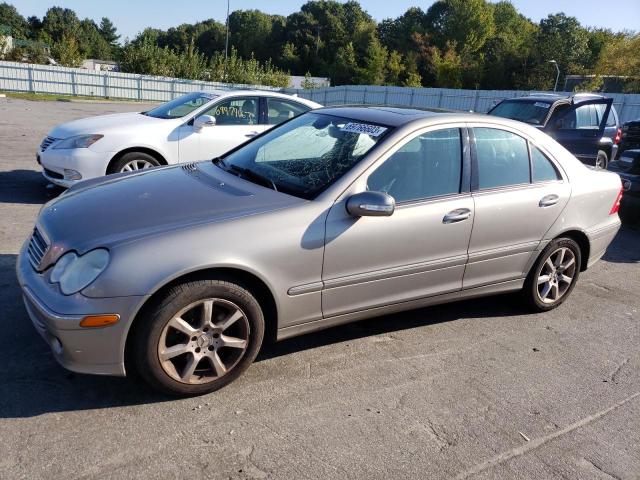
left=216, top=113, right=391, bottom=199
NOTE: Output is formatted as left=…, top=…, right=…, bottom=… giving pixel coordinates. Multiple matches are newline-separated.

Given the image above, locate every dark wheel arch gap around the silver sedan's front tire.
left=124, top=267, right=278, bottom=372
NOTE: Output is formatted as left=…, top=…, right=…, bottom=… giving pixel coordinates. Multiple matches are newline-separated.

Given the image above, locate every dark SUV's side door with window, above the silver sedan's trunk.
left=545, top=98, right=615, bottom=165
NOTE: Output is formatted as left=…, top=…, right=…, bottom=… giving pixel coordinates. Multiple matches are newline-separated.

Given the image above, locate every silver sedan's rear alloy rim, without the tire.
left=537, top=247, right=576, bottom=304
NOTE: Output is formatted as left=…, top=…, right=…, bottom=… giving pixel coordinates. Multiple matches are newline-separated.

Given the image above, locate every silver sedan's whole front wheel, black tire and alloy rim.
left=134, top=280, right=264, bottom=396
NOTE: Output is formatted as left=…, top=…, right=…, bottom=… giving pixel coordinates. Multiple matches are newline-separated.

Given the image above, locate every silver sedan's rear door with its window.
left=463, top=127, right=571, bottom=289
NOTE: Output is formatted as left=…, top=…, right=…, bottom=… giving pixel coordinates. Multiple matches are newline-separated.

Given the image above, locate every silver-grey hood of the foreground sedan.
left=38, top=162, right=305, bottom=262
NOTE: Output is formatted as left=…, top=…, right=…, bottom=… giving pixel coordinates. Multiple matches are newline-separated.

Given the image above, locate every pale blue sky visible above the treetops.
left=10, top=0, right=640, bottom=40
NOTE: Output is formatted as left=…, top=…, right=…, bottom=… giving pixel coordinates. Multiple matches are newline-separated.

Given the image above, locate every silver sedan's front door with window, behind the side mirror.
left=322, top=126, right=474, bottom=317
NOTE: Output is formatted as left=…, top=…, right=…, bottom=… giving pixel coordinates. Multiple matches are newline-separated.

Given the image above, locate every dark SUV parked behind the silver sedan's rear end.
left=488, top=93, right=622, bottom=168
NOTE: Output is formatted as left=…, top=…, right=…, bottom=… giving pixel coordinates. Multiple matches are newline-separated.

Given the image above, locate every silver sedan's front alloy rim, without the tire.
left=158, top=298, right=250, bottom=384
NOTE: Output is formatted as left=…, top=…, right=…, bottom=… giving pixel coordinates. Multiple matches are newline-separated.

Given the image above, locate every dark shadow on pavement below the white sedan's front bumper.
left=0, top=170, right=64, bottom=204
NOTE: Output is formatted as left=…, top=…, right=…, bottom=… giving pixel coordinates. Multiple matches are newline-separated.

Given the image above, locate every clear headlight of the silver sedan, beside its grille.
left=50, top=248, right=109, bottom=295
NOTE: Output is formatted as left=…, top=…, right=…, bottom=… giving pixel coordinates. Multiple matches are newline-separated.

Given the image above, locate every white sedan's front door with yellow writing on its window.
left=179, top=97, right=265, bottom=162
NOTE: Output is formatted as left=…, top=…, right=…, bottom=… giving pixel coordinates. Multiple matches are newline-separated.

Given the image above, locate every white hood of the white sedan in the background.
left=48, top=112, right=171, bottom=138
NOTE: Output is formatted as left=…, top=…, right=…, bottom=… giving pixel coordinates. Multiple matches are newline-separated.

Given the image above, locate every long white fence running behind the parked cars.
left=0, top=61, right=640, bottom=122
